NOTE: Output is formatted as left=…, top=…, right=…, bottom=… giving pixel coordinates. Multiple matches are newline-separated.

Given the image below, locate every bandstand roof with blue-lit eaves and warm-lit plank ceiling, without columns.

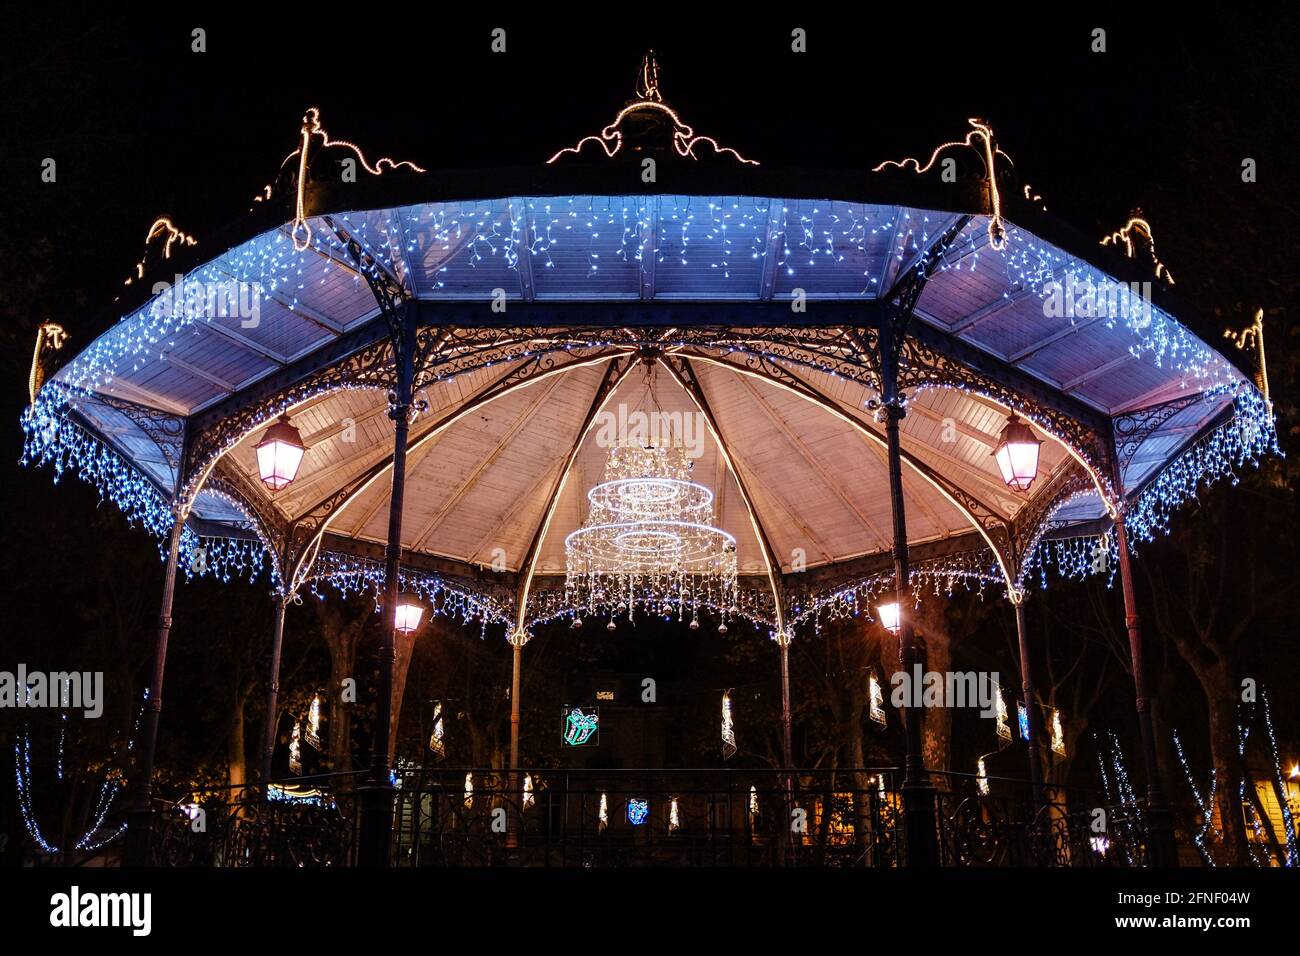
left=29, top=67, right=1273, bottom=634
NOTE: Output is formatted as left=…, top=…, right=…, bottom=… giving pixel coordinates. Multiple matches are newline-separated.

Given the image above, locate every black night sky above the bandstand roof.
left=4, top=13, right=1296, bottom=329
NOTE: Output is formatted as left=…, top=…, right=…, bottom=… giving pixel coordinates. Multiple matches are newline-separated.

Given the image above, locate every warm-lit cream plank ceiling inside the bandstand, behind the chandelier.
left=208, top=348, right=1069, bottom=574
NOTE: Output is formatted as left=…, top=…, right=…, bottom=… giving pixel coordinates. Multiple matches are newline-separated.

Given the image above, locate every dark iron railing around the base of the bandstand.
left=126, top=767, right=1147, bottom=868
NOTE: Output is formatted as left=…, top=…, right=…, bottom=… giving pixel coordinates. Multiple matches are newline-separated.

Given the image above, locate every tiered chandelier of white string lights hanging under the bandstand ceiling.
left=564, top=445, right=736, bottom=633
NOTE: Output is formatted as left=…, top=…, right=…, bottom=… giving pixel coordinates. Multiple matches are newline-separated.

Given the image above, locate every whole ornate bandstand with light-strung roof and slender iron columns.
left=23, top=57, right=1275, bottom=862
